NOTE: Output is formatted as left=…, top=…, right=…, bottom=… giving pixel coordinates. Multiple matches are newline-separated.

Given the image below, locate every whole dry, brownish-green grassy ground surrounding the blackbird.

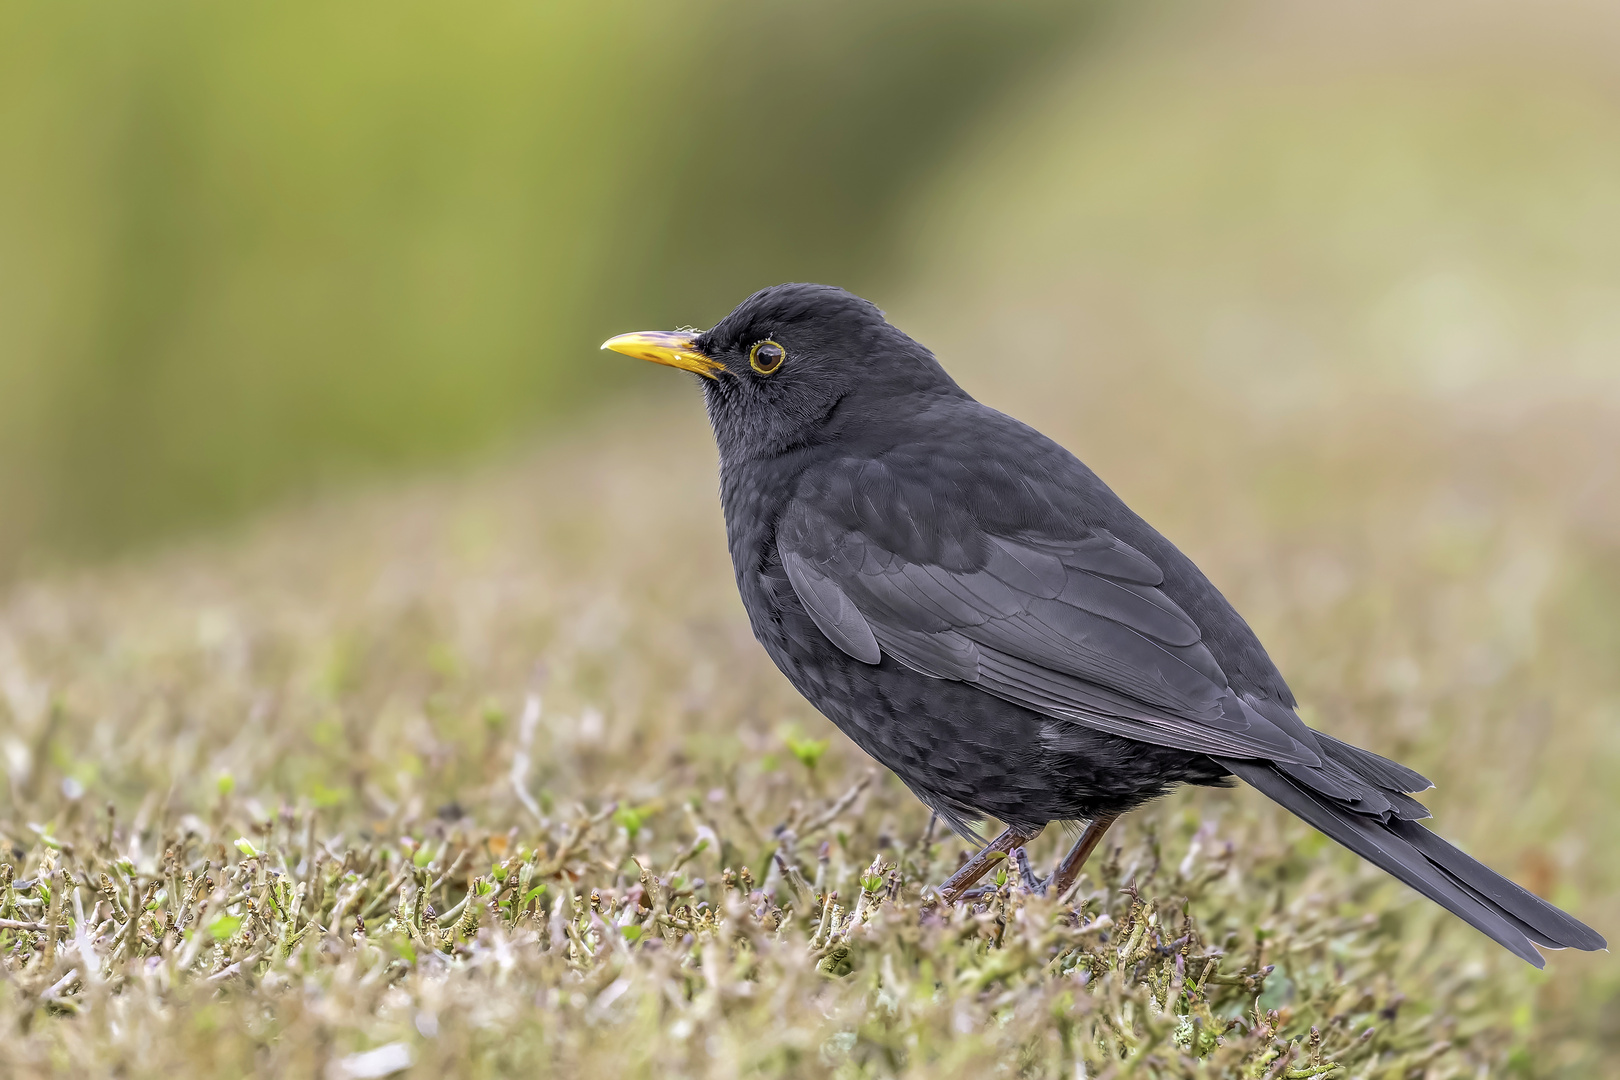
left=0, top=381, right=1620, bottom=1077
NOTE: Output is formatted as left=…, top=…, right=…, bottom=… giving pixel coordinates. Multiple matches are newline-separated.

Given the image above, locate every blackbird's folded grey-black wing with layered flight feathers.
left=776, top=500, right=1337, bottom=772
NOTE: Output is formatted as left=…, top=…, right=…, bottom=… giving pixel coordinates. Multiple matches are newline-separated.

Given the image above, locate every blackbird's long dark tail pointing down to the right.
left=1221, top=755, right=1607, bottom=967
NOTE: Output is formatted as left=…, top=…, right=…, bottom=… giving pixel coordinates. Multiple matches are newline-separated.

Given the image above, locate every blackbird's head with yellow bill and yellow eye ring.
left=603, top=285, right=961, bottom=458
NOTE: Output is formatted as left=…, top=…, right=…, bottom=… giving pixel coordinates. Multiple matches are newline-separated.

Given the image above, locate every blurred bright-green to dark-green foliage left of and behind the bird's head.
left=0, top=0, right=1097, bottom=572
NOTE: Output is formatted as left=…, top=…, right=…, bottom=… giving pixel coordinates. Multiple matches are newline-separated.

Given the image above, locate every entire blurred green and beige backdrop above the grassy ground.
left=0, top=0, right=1620, bottom=580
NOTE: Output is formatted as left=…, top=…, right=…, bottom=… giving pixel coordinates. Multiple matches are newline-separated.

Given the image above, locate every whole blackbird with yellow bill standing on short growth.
left=603, top=285, right=1605, bottom=967
